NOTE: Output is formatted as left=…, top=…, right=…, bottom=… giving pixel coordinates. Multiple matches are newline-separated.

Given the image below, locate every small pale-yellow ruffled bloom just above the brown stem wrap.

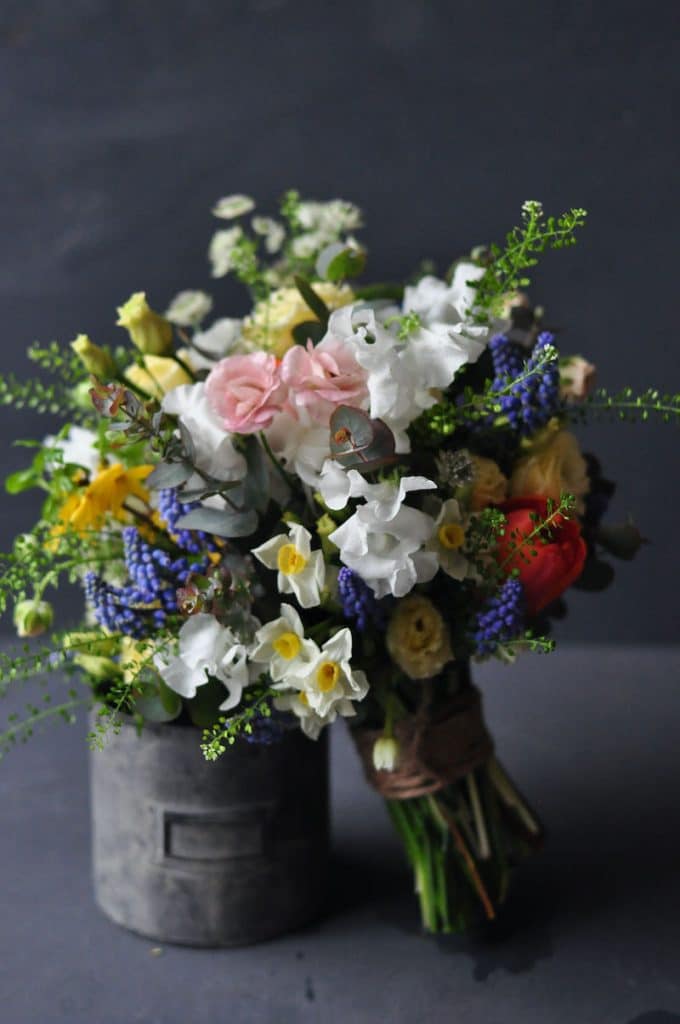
left=386, top=594, right=454, bottom=679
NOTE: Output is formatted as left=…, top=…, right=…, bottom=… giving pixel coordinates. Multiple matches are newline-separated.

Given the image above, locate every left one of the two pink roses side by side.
left=206, top=352, right=284, bottom=434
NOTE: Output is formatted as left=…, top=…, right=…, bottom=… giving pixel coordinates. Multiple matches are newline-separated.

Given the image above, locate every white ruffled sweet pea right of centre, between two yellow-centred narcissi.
left=329, top=476, right=438, bottom=598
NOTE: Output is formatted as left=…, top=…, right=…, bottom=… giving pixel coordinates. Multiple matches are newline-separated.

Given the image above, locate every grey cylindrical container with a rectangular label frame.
left=90, top=722, right=329, bottom=946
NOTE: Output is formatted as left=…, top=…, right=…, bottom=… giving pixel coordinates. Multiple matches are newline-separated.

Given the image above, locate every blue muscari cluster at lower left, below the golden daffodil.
left=85, top=526, right=208, bottom=638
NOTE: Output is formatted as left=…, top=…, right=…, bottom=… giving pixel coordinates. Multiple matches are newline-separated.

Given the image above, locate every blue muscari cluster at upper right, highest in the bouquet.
left=488, top=331, right=560, bottom=435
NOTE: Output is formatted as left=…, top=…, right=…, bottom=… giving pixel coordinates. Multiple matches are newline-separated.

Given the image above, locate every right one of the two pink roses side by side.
left=281, top=338, right=368, bottom=424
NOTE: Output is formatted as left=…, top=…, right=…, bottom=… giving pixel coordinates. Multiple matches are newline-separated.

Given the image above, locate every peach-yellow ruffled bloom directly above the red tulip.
left=510, top=424, right=590, bottom=515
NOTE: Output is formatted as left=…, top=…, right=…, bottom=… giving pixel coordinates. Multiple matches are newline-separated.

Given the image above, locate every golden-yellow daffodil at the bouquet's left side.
left=53, top=463, right=154, bottom=537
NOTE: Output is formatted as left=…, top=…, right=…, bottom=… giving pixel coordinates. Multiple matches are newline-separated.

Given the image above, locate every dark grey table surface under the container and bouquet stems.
left=0, top=647, right=680, bottom=1024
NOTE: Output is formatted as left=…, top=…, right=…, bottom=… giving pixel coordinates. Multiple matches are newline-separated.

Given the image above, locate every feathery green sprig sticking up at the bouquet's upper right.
left=474, top=200, right=587, bottom=322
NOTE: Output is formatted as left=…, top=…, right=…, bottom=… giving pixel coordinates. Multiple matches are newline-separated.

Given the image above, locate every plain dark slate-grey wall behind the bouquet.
left=0, top=0, right=680, bottom=642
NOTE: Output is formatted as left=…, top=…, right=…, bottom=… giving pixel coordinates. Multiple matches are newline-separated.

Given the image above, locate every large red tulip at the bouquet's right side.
left=497, top=496, right=588, bottom=615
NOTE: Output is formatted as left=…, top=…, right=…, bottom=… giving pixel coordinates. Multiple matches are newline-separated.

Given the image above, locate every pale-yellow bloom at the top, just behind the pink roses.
left=243, top=281, right=354, bottom=358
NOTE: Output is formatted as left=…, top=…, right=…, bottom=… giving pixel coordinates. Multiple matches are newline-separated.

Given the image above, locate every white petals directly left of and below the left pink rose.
left=162, top=383, right=247, bottom=480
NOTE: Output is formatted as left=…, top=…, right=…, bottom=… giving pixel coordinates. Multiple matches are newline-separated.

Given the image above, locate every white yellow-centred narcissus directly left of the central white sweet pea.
left=252, top=522, right=326, bottom=608
